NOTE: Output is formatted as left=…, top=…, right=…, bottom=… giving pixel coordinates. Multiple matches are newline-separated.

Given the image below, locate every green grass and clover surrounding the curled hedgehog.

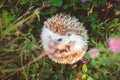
left=0, top=0, right=120, bottom=80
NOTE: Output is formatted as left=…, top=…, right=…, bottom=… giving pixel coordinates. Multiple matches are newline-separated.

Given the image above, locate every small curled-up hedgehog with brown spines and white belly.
left=40, top=13, right=88, bottom=64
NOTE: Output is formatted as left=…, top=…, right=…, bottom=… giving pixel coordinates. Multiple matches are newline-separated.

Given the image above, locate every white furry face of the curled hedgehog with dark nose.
left=41, top=27, right=67, bottom=50
